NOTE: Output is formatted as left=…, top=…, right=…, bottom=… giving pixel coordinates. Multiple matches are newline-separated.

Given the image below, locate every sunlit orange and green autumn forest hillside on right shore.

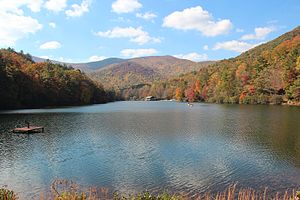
left=119, top=27, right=300, bottom=104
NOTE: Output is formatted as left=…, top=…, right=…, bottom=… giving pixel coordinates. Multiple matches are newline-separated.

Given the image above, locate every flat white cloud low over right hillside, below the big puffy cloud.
left=213, top=40, right=259, bottom=53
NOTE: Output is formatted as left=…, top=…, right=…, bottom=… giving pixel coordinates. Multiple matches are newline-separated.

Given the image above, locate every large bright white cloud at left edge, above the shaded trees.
left=0, top=11, right=42, bottom=47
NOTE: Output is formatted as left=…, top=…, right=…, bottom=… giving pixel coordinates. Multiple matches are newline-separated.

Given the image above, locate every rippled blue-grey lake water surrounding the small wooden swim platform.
left=0, top=102, right=300, bottom=199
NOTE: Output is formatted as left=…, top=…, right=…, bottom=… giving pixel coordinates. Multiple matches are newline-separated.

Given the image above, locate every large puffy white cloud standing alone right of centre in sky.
left=163, top=6, right=233, bottom=36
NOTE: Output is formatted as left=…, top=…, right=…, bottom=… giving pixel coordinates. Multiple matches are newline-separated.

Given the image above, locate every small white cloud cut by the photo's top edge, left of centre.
left=111, top=0, right=143, bottom=14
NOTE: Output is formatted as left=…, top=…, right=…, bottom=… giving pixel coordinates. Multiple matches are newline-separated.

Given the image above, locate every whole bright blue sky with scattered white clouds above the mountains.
left=0, top=0, right=300, bottom=62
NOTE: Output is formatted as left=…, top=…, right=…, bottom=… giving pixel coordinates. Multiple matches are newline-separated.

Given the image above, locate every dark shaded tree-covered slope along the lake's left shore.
left=0, top=48, right=114, bottom=109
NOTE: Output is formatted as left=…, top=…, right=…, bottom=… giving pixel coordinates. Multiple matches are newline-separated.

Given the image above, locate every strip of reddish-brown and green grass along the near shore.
left=0, top=180, right=300, bottom=200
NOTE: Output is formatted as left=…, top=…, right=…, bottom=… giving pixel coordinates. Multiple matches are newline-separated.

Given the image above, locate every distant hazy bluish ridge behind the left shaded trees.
left=32, top=56, right=126, bottom=73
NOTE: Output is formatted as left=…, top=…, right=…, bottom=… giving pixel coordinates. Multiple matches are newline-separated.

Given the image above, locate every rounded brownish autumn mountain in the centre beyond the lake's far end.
left=89, top=56, right=214, bottom=90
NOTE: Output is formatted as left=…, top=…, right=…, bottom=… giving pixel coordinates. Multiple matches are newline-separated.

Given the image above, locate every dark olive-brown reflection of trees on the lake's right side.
left=222, top=105, right=300, bottom=167
